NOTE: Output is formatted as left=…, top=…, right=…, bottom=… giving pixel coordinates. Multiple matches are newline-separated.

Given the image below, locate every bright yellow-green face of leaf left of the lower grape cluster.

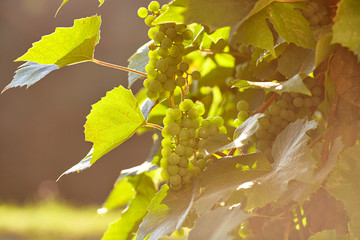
left=84, top=86, right=145, bottom=163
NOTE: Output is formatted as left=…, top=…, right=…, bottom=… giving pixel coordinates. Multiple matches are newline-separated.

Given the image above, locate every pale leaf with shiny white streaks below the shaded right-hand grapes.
left=244, top=119, right=317, bottom=210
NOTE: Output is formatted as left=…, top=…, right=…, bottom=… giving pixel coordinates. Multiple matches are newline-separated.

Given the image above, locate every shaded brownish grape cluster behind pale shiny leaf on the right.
left=252, top=78, right=322, bottom=157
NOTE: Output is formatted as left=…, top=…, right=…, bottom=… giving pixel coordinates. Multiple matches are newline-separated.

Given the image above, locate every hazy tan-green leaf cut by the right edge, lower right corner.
left=326, top=146, right=360, bottom=238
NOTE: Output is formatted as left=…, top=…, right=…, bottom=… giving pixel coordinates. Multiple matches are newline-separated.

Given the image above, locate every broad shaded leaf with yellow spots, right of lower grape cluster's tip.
left=196, top=152, right=272, bottom=213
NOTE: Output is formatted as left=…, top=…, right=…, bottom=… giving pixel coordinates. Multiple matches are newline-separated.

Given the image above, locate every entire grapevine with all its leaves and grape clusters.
left=4, top=0, right=360, bottom=240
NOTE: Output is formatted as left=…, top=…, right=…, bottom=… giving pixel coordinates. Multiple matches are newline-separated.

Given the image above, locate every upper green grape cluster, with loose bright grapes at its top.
left=138, top=1, right=201, bottom=100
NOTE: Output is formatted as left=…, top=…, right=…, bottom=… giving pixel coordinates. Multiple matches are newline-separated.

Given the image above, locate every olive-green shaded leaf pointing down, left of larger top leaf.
left=232, top=9, right=276, bottom=57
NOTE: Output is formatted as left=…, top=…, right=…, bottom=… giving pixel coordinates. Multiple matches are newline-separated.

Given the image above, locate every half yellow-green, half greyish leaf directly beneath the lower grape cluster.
left=136, top=183, right=199, bottom=240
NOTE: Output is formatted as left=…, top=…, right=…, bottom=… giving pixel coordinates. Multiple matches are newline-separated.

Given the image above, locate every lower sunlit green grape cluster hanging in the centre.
left=160, top=99, right=226, bottom=190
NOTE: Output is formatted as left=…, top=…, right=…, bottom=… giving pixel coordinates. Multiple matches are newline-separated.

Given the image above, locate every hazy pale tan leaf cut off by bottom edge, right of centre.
left=189, top=206, right=250, bottom=240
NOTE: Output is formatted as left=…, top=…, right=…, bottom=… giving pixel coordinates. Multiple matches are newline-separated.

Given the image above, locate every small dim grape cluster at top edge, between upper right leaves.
left=301, top=1, right=330, bottom=29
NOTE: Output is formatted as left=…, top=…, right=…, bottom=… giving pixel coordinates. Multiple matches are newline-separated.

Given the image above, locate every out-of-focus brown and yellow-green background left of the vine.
left=0, top=0, right=165, bottom=239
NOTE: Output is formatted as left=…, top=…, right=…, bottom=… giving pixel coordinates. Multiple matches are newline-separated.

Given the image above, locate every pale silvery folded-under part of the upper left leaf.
left=2, top=62, right=59, bottom=93
